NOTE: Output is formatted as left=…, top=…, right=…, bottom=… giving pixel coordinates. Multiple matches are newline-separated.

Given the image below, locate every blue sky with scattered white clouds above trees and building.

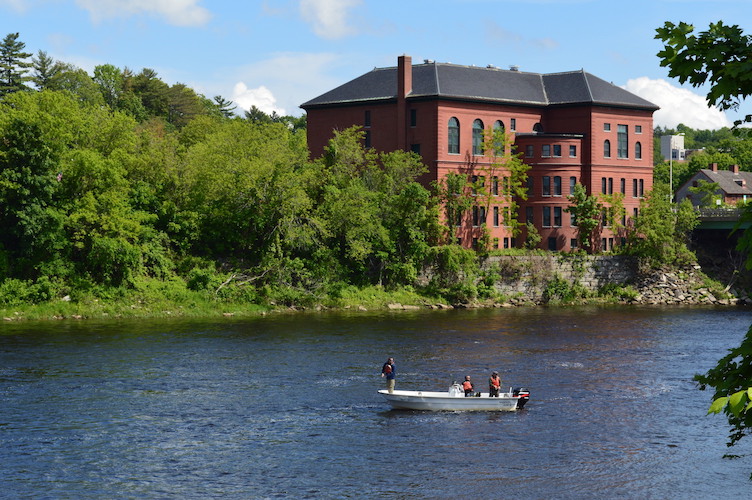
left=0, top=0, right=752, bottom=128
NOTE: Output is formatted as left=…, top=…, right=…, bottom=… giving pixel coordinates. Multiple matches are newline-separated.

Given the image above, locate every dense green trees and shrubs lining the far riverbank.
left=0, top=34, right=740, bottom=319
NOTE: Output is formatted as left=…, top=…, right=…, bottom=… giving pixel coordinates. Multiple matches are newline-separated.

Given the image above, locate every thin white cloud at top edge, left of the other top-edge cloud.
left=76, top=0, right=211, bottom=26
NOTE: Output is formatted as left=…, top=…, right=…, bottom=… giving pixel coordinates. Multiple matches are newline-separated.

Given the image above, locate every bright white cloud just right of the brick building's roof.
left=624, top=76, right=732, bottom=130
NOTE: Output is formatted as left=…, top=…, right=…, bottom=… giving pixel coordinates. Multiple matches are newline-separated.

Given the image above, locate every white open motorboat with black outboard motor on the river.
left=379, top=384, right=530, bottom=411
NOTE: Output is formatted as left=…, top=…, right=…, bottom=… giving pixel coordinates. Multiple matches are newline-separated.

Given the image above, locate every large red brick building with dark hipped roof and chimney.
left=301, top=56, right=658, bottom=250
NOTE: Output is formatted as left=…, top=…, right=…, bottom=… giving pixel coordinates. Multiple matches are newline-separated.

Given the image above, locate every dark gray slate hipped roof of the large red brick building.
left=300, top=62, right=658, bottom=111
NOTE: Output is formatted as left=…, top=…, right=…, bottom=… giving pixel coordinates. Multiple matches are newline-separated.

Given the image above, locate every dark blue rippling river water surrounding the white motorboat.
left=0, top=307, right=752, bottom=499
